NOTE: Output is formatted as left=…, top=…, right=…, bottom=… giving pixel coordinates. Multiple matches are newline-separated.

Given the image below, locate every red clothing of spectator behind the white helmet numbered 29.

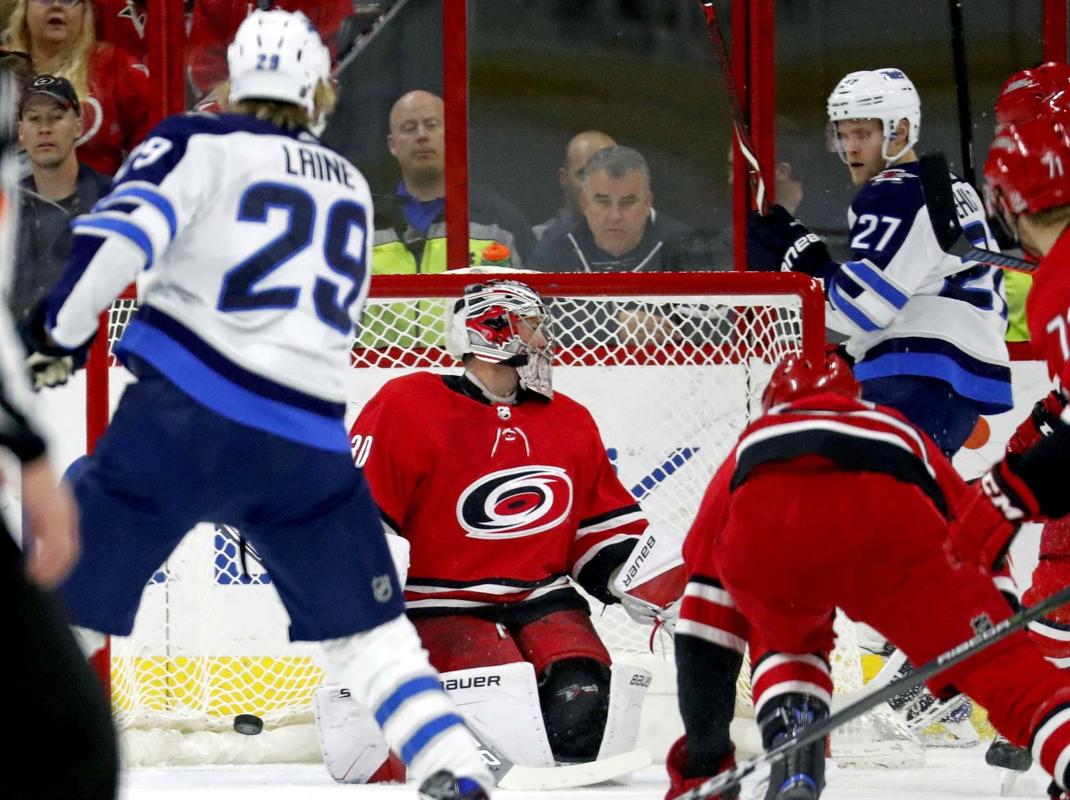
left=185, top=0, right=353, bottom=99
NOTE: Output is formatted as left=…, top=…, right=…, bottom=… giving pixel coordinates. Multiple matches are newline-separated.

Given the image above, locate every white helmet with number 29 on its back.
left=227, top=10, right=331, bottom=117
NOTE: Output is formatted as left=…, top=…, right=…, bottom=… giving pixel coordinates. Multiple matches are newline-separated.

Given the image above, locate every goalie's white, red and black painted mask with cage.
left=446, top=280, right=553, bottom=397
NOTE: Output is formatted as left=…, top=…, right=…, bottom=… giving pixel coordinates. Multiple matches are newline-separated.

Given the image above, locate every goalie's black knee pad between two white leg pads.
left=539, top=659, right=610, bottom=761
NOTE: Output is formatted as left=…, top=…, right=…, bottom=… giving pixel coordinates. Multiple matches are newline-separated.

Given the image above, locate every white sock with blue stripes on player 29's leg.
left=322, top=615, right=493, bottom=787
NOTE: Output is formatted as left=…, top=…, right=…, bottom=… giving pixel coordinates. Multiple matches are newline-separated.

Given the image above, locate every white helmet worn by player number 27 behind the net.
left=828, top=67, right=921, bottom=167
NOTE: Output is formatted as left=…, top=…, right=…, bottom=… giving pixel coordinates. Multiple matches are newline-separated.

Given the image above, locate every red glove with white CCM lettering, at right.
left=948, top=461, right=1039, bottom=567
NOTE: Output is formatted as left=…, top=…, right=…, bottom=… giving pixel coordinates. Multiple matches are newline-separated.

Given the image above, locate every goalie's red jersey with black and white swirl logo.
left=350, top=372, right=647, bottom=621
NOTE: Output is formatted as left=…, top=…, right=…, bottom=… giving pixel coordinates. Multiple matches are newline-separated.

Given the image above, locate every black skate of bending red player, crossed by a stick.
left=759, top=693, right=828, bottom=800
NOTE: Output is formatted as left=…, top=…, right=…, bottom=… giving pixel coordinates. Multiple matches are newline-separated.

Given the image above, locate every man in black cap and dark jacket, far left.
left=7, top=75, right=111, bottom=319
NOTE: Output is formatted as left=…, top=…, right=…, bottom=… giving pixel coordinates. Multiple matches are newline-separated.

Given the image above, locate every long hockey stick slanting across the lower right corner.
left=673, top=586, right=1070, bottom=800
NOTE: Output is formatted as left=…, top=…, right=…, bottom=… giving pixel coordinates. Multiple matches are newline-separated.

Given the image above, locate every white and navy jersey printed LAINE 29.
left=50, top=114, right=372, bottom=432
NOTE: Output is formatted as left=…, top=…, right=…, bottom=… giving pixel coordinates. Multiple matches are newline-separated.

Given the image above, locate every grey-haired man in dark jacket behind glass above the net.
left=534, top=147, right=688, bottom=273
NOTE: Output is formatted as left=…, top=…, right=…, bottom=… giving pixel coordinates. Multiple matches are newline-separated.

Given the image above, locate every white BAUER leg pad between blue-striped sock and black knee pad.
left=442, top=661, right=554, bottom=767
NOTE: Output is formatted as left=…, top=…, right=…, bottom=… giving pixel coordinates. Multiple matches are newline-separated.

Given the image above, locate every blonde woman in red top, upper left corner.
left=4, top=0, right=149, bottom=175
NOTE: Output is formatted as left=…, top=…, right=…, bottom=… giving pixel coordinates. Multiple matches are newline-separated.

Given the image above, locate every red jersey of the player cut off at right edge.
left=1025, top=227, right=1070, bottom=396
